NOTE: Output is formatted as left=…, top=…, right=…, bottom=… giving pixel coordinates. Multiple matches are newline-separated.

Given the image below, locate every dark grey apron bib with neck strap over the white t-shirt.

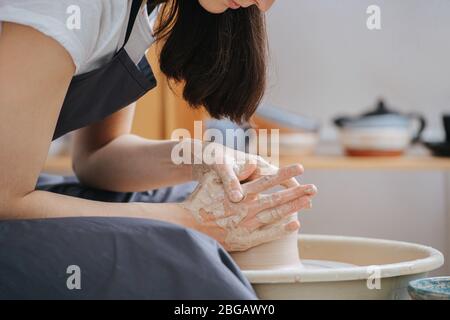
left=53, top=0, right=156, bottom=139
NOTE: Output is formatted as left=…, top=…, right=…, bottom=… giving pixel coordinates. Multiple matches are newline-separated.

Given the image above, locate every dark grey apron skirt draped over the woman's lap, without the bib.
left=0, top=177, right=256, bottom=299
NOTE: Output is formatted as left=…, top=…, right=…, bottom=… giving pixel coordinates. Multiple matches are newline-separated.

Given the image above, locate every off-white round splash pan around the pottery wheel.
left=243, top=235, right=444, bottom=299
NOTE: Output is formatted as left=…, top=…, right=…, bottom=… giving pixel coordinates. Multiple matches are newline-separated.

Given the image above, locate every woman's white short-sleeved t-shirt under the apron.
left=0, top=0, right=157, bottom=74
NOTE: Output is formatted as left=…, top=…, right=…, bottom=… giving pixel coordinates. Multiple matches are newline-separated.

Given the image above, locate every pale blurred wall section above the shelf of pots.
left=267, top=0, right=450, bottom=138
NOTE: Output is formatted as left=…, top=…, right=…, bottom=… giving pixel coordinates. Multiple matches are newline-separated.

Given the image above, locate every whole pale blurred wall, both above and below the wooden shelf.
left=266, top=0, right=450, bottom=273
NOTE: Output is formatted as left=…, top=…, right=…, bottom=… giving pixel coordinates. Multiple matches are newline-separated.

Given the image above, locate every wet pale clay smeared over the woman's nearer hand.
left=182, top=167, right=316, bottom=251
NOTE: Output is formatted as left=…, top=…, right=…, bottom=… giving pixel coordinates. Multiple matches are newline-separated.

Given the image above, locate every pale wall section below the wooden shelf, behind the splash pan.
left=299, top=170, right=450, bottom=274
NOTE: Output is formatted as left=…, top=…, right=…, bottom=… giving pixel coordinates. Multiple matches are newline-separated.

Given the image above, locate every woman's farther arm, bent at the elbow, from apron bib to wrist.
left=73, top=104, right=192, bottom=192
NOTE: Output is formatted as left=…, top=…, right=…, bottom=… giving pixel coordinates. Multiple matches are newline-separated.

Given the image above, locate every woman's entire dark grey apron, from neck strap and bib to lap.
left=0, top=0, right=255, bottom=299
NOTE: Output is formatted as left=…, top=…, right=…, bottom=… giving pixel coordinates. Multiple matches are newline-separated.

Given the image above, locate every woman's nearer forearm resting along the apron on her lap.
left=0, top=191, right=194, bottom=227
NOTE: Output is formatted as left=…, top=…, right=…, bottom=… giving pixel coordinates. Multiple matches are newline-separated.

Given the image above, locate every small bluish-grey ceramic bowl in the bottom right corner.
left=408, top=277, right=450, bottom=300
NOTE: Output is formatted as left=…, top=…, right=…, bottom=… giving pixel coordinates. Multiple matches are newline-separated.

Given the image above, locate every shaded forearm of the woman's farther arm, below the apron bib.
left=74, top=134, right=192, bottom=192
